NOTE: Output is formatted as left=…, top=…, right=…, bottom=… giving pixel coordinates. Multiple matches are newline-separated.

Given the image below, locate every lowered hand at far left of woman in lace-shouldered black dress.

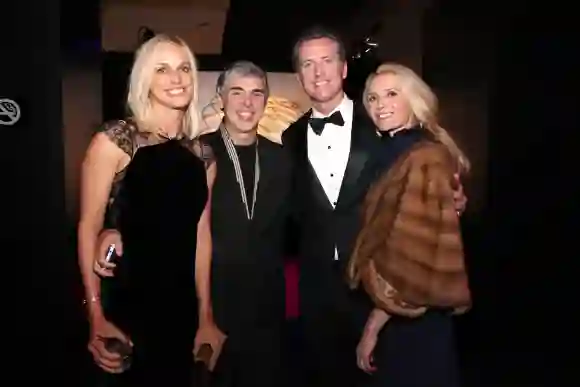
left=88, top=318, right=133, bottom=374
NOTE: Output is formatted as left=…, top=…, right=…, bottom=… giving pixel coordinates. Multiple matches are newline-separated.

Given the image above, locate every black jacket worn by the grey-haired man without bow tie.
left=201, top=131, right=293, bottom=332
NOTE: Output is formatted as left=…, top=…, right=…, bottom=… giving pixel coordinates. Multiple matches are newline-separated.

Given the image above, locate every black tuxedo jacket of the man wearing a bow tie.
left=282, top=104, right=380, bottom=315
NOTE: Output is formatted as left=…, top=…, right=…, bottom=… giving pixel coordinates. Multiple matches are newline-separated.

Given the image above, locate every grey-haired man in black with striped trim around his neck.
left=202, top=61, right=292, bottom=387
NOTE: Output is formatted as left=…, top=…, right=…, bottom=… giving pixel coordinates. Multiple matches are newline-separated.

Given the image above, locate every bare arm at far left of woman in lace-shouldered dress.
left=77, top=133, right=128, bottom=320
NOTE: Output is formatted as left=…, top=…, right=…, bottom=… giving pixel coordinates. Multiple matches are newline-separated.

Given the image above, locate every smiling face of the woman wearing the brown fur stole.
left=365, top=73, right=415, bottom=131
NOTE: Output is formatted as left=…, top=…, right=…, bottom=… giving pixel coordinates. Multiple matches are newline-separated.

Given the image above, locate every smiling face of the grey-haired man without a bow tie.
left=221, top=72, right=268, bottom=133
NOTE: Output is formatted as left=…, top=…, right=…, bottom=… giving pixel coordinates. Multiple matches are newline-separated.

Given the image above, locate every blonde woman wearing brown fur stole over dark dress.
left=348, top=64, right=471, bottom=387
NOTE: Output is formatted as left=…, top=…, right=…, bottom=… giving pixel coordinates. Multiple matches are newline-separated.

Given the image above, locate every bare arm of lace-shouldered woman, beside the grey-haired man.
left=195, top=162, right=217, bottom=325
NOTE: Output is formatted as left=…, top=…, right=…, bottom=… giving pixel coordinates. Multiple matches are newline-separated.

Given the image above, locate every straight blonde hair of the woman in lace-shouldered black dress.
left=127, top=34, right=201, bottom=138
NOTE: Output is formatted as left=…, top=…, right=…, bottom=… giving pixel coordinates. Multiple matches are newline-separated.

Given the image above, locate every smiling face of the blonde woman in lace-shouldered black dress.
left=149, top=42, right=193, bottom=109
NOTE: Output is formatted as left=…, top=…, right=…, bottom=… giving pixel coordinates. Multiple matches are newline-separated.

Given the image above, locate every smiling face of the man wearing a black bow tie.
left=297, top=38, right=347, bottom=109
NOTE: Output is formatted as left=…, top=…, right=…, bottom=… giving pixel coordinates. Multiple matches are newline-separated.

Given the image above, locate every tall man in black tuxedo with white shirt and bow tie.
left=282, top=28, right=465, bottom=387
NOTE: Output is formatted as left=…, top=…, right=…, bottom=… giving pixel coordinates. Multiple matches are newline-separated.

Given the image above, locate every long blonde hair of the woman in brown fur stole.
left=363, top=63, right=471, bottom=172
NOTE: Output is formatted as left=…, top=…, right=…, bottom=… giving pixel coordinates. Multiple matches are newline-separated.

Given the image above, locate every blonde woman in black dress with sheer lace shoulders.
left=78, top=35, right=224, bottom=387
